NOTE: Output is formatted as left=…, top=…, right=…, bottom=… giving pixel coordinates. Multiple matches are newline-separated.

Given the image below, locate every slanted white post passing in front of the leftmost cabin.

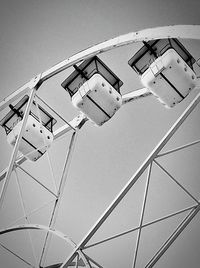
left=0, top=87, right=36, bottom=210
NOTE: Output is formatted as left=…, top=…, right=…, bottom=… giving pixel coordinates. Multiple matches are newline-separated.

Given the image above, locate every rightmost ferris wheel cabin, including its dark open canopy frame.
left=128, top=38, right=196, bottom=108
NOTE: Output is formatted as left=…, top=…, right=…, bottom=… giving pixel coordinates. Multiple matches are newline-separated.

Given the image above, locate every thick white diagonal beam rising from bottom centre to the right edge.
left=61, top=90, right=200, bottom=268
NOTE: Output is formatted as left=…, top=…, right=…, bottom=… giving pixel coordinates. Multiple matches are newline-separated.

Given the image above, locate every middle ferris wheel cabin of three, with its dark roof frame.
left=61, top=56, right=123, bottom=126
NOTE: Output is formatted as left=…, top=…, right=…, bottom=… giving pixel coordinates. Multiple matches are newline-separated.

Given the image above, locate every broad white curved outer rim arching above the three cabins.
left=0, top=25, right=200, bottom=111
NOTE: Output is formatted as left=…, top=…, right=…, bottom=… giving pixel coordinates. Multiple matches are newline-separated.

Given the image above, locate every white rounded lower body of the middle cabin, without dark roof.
left=72, top=74, right=122, bottom=126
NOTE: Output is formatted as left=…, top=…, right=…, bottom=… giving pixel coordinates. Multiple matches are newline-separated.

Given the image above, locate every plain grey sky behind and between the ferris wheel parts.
left=0, top=0, right=200, bottom=268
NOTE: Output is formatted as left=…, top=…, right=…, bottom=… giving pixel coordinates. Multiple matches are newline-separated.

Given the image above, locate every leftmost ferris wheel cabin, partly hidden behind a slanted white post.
left=0, top=95, right=57, bottom=161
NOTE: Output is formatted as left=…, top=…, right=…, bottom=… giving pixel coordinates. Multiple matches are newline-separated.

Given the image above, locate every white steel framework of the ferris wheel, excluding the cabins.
left=0, top=25, right=200, bottom=268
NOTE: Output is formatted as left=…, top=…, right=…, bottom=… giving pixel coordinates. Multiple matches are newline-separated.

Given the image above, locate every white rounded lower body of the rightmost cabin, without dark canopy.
left=141, top=49, right=196, bottom=108
